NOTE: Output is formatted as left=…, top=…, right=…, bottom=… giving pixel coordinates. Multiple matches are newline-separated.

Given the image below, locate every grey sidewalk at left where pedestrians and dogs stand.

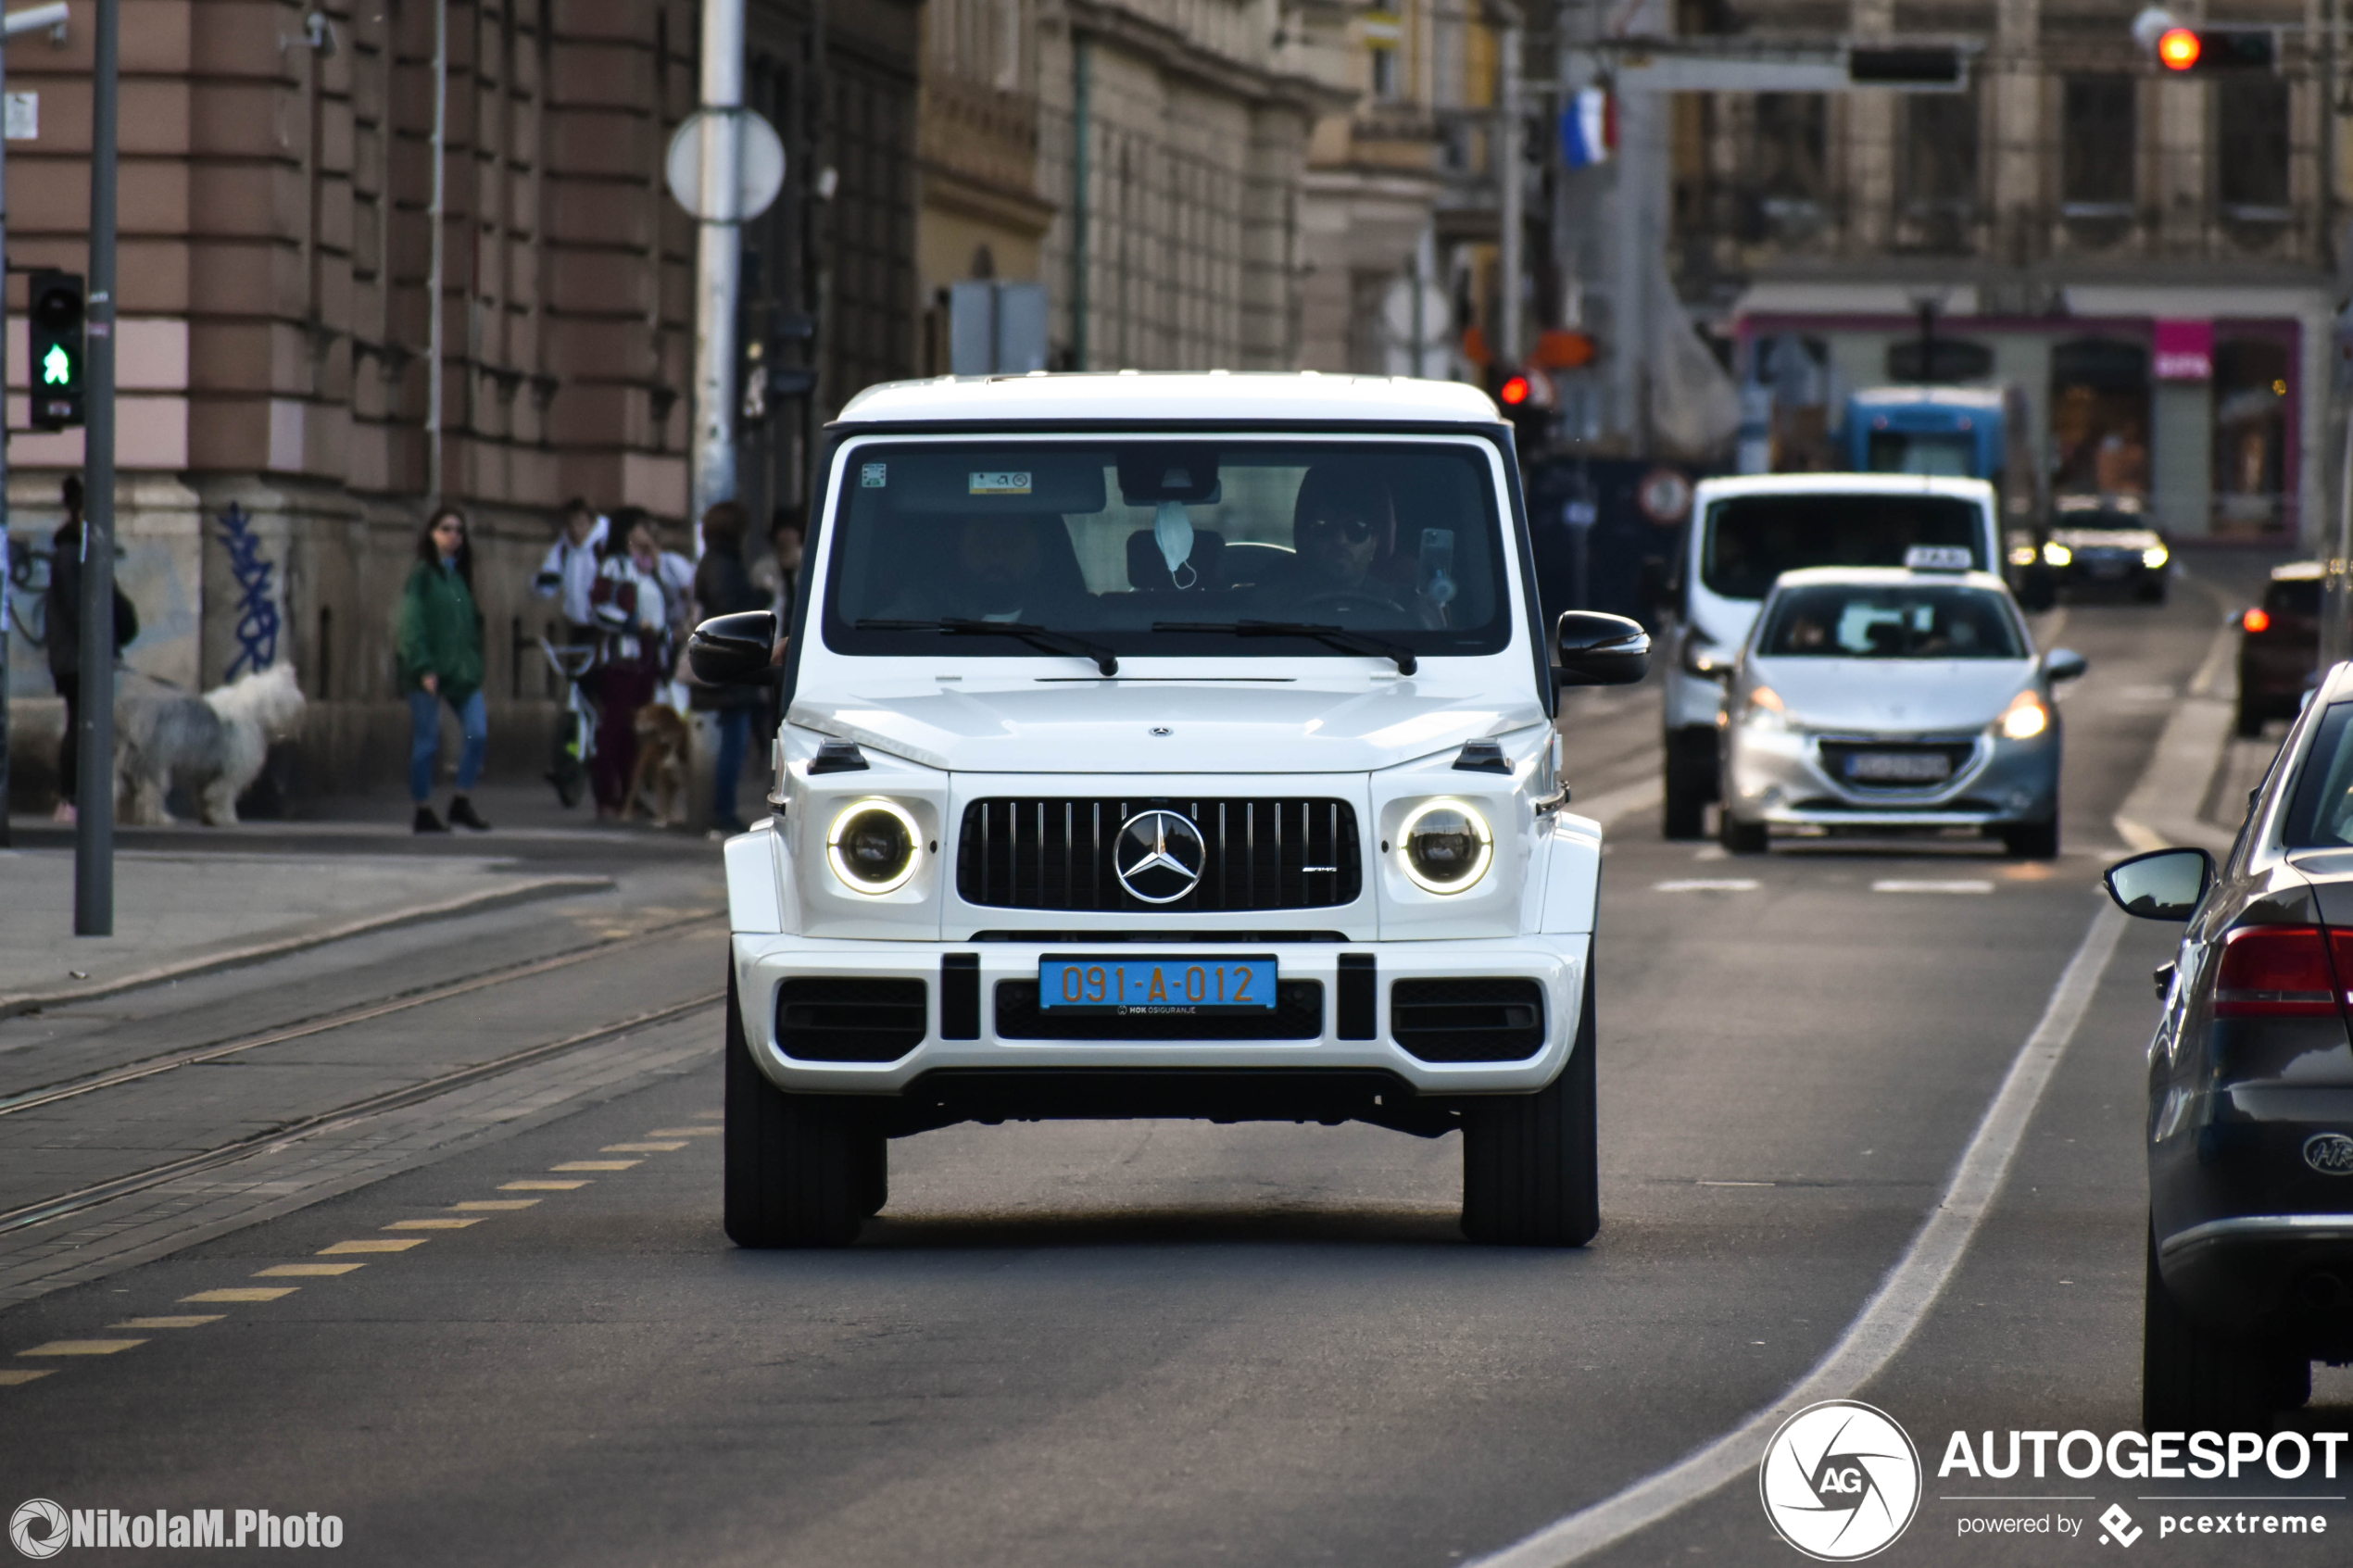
left=0, top=846, right=614, bottom=1018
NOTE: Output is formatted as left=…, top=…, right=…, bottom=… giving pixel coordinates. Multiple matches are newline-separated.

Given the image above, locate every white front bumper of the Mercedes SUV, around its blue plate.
left=734, top=934, right=1591, bottom=1096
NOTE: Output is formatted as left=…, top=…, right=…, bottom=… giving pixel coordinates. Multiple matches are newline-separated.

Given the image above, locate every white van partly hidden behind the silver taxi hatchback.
left=1661, top=472, right=2003, bottom=839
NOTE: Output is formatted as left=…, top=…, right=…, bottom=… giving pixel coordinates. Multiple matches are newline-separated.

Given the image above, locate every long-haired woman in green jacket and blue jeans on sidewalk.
left=397, top=506, right=489, bottom=833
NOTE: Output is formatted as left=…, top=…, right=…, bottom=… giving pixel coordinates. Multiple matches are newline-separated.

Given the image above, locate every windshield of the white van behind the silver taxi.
left=1699, top=496, right=1988, bottom=599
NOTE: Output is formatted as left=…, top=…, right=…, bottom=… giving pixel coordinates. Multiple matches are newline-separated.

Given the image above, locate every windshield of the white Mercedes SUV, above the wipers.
left=824, top=437, right=1511, bottom=659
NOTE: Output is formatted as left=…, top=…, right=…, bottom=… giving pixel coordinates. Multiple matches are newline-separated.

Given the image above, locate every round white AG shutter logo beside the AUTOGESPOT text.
left=1757, top=1399, right=1920, bottom=1563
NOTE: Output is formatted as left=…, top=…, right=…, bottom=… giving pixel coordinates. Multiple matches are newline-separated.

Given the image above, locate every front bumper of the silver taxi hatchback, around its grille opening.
left=1725, top=724, right=2059, bottom=827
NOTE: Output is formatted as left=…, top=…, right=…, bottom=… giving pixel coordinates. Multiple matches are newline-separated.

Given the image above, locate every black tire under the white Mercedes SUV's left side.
left=723, top=966, right=889, bottom=1248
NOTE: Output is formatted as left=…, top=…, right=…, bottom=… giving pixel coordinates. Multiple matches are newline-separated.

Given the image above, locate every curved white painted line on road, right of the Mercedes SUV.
left=1476, top=908, right=2125, bottom=1568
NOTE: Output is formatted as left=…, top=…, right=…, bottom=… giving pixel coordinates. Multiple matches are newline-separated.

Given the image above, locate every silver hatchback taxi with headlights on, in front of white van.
left=1718, top=564, right=2084, bottom=858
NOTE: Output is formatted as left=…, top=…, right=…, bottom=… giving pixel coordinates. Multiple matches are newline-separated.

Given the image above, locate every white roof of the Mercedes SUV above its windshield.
left=837, top=370, right=1502, bottom=425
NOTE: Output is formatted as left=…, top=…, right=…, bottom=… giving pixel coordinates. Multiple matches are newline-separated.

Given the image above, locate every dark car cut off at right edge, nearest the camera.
left=2108, top=665, right=2353, bottom=1429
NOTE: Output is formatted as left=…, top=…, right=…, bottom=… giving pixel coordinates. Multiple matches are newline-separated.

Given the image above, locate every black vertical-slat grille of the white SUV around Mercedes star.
left=955, top=797, right=1365, bottom=914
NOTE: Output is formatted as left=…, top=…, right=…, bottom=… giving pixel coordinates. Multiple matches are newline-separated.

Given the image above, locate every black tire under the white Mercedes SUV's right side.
left=1464, top=957, right=1603, bottom=1246
